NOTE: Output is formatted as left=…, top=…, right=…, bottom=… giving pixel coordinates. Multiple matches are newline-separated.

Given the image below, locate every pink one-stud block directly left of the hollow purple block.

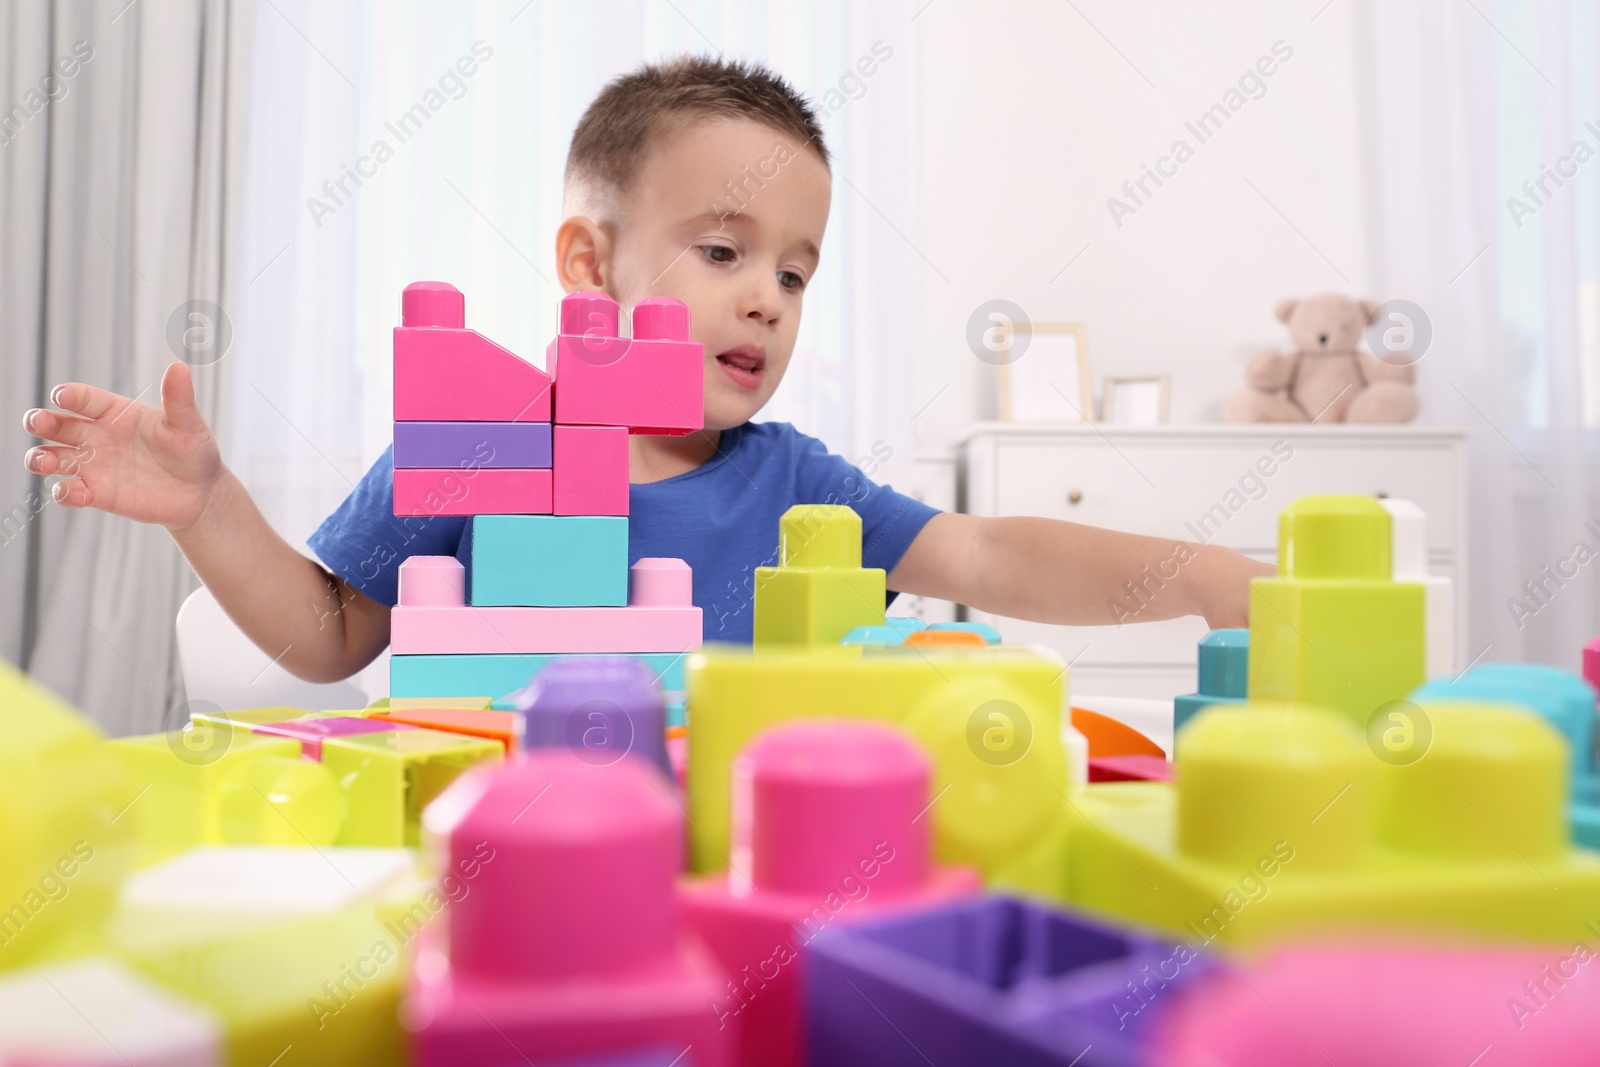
left=682, top=720, right=979, bottom=1067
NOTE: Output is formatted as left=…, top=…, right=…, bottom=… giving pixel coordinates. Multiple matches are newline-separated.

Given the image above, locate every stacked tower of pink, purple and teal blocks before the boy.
left=390, top=282, right=704, bottom=712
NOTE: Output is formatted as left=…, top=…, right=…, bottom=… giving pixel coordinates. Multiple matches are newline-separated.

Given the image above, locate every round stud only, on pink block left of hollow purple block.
left=733, top=720, right=933, bottom=896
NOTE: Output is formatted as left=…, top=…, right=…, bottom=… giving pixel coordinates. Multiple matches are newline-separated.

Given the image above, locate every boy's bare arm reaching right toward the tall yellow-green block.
left=888, top=512, right=1274, bottom=629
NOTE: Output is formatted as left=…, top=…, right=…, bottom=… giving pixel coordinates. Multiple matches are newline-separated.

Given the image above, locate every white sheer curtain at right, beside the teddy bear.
left=1357, top=0, right=1600, bottom=665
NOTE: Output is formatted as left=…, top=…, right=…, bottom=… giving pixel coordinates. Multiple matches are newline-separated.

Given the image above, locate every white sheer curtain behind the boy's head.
left=229, top=0, right=912, bottom=542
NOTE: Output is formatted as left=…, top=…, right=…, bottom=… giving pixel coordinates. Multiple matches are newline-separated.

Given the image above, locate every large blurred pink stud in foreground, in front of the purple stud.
left=422, top=749, right=683, bottom=981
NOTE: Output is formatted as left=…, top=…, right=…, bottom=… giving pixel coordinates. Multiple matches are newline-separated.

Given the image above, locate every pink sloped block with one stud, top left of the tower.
left=395, top=282, right=555, bottom=422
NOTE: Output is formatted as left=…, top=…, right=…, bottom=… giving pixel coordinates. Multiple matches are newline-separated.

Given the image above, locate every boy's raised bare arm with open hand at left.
left=22, top=363, right=389, bottom=681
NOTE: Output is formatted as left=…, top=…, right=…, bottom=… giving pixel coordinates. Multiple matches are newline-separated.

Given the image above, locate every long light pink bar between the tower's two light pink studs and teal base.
left=389, top=605, right=704, bottom=656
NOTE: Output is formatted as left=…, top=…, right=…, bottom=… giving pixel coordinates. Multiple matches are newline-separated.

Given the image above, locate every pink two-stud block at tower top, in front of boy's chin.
left=546, top=293, right=706, bottom=437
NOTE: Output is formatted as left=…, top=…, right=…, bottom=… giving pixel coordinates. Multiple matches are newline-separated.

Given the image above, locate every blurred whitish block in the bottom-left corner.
left=0, top=955, right=224, bottom=1067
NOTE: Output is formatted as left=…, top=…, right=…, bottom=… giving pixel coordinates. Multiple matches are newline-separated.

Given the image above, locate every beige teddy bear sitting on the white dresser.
left=1222, top=293, right=1419, bottom=422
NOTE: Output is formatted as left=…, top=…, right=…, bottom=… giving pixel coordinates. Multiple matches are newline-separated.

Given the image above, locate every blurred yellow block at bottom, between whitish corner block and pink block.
left=114, top=904, right=410, bottom=1067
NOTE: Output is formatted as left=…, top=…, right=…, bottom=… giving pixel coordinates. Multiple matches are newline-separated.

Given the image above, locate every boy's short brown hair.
left=565, top=56, right=827, bottom=214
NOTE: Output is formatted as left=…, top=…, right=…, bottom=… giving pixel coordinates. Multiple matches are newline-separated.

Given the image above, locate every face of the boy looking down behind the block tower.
left=610, top=120, right=832, bottom=430
